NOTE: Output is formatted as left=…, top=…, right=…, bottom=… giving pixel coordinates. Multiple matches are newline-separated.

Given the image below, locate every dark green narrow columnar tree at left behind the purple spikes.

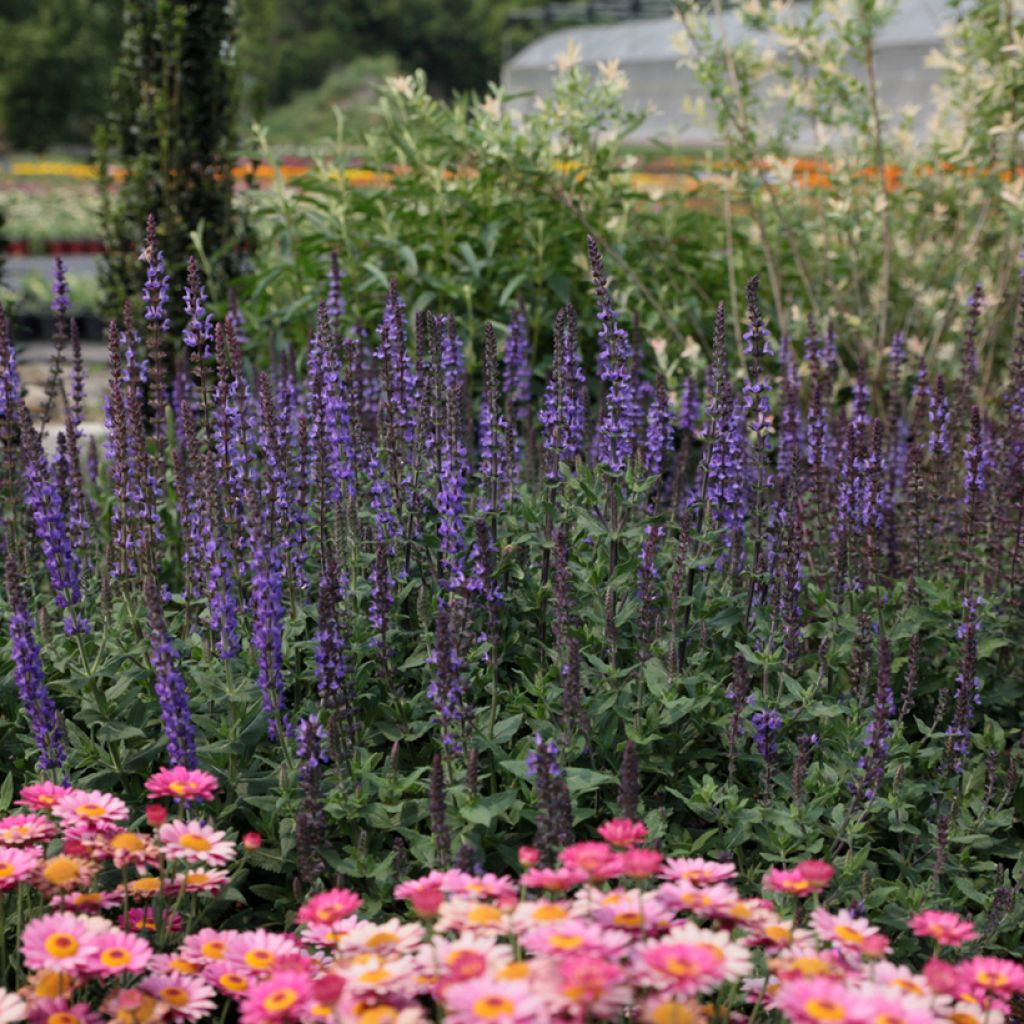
left=97, top=0, right=245, bottom=319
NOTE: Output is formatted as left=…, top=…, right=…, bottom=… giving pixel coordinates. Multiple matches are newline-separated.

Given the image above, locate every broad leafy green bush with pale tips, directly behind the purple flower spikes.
left=241, top=67, right=724, bottom=364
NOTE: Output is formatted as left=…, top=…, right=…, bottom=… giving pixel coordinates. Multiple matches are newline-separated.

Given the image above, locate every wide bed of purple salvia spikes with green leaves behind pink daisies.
left=0, top=223, right=1024, bottom=962
